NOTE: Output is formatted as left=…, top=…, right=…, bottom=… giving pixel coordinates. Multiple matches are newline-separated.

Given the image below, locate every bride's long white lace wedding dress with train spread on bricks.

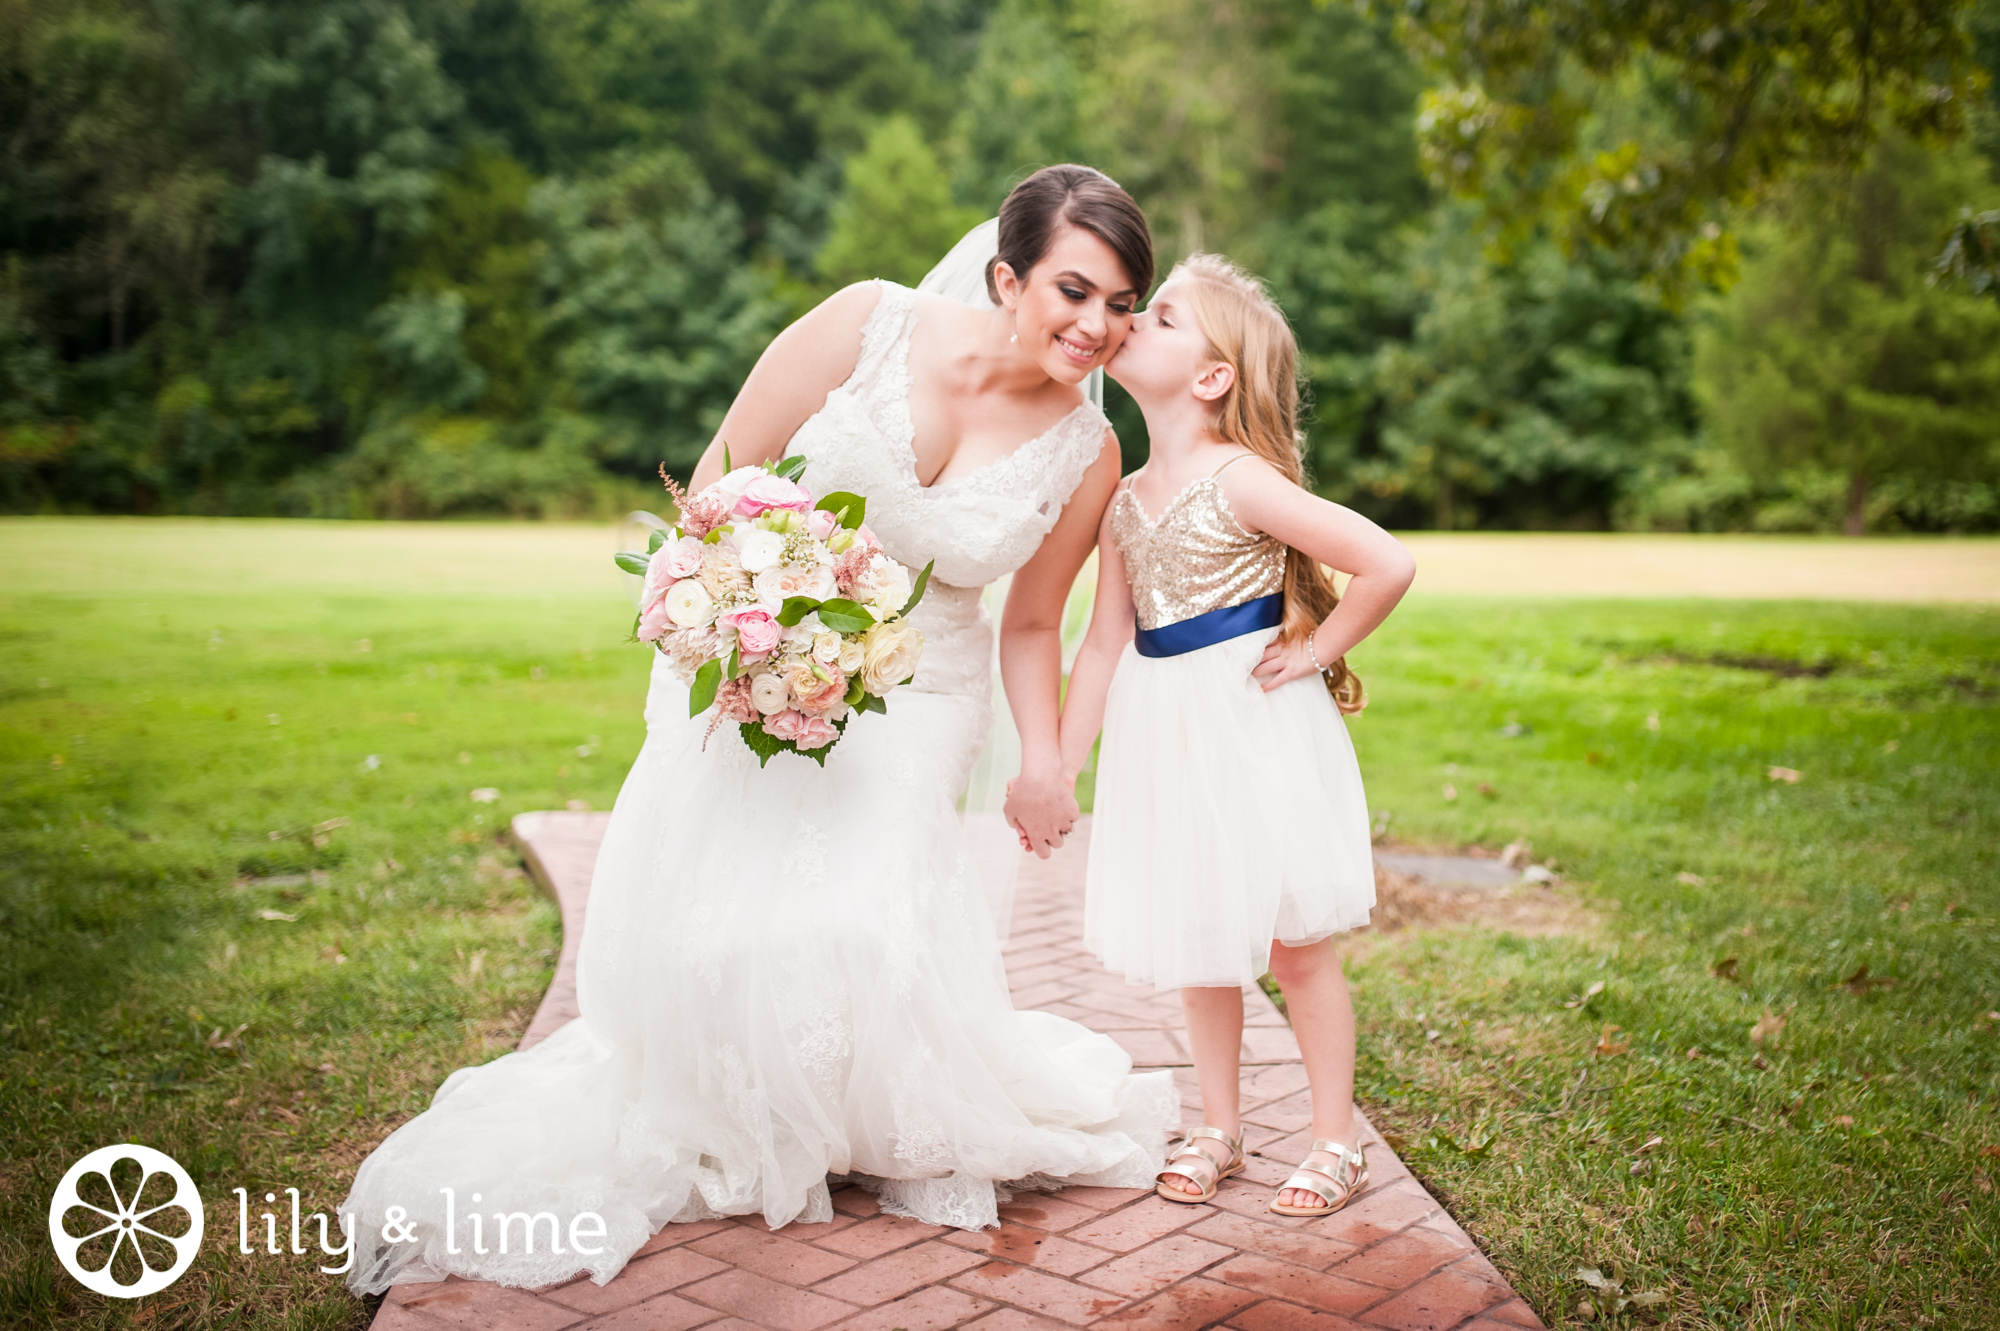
left=342, top=282, right=1180, bottom=1293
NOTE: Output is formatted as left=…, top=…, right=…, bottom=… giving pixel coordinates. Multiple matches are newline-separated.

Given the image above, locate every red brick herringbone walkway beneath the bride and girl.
left=374, top=813, right=1542, bottom=1331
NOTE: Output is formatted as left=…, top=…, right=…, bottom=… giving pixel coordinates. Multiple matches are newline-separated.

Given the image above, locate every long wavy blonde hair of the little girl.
left=1162, top=254, right=1368, bottom=713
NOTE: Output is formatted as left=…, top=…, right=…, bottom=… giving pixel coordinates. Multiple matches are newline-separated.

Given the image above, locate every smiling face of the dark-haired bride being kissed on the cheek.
left=994, top=224, right=1138, bottom=384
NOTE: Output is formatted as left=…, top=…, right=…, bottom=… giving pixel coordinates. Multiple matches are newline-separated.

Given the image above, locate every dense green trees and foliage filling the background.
left=0, top=0, right=2000, bottom=530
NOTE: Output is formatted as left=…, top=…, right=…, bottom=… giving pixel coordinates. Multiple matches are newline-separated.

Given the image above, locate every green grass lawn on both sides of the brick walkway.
left=0, top=520, right=2000, bottom=1327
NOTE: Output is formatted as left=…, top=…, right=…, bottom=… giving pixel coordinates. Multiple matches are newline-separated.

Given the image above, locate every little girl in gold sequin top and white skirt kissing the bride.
left=1062, top=256, right=1416, bottom=1215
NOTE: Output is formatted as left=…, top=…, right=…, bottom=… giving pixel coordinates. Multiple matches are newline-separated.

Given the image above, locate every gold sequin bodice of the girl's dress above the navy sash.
left=1112, top=476, right=1284, bottom=630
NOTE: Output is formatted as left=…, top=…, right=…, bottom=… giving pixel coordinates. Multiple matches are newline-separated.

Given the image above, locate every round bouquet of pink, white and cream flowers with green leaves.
left=618, top=458, right=936, bottom=767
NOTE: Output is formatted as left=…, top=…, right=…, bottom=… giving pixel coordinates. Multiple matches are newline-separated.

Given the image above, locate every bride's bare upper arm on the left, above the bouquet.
left=688, top=282, right=882, bottom=490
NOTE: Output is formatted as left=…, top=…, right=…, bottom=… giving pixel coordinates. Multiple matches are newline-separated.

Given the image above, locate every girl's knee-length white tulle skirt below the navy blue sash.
left=1084, top=630, right=1374, bottom=989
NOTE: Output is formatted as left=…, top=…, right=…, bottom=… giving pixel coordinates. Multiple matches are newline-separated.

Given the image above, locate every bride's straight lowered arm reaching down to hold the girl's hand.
left=1000, top=430, right=1118, bottom=859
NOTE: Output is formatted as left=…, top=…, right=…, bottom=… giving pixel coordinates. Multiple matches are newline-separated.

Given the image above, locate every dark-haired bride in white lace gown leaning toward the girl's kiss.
left=340, top=166, right=1180, bottom=1293
